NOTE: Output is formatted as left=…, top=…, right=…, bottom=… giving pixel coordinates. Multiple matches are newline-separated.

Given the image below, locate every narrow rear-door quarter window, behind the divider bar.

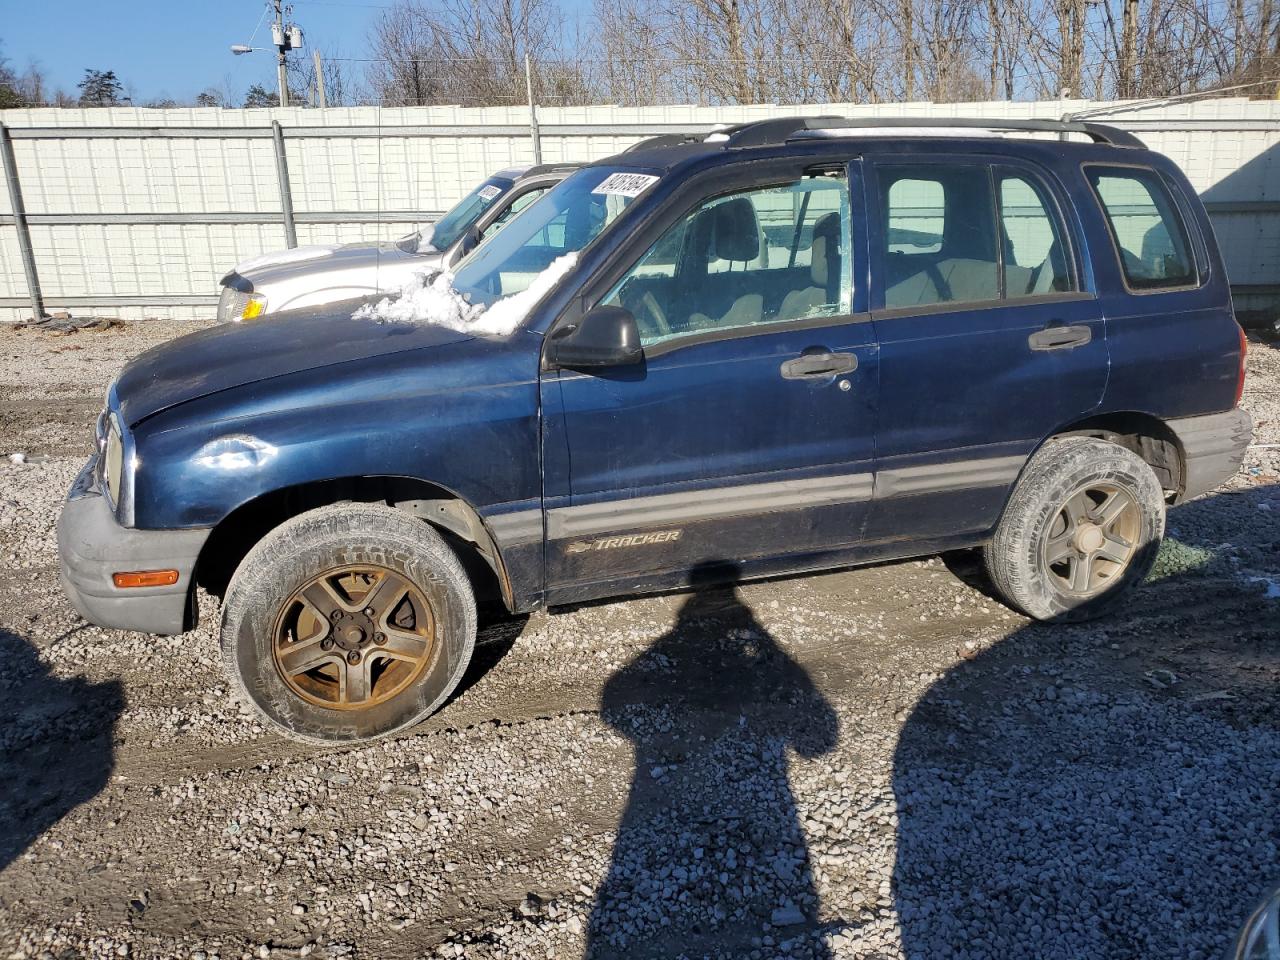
left=997, top=172, right=1075, bottom=300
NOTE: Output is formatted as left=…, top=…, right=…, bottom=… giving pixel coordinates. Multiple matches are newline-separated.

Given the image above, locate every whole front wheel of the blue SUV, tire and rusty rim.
left=221, top=504, right=476, bottom=742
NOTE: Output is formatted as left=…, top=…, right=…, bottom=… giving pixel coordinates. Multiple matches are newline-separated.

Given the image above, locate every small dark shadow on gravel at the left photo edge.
left=0, top=630, right=124, bottom=870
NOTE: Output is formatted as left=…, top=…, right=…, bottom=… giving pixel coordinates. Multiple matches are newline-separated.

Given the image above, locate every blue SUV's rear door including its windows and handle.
left=867, top=157, right=1107, bottom=545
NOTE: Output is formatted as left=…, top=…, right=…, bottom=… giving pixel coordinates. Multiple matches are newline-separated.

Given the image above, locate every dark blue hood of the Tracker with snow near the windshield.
left=114, top=301, right=474, bottom=426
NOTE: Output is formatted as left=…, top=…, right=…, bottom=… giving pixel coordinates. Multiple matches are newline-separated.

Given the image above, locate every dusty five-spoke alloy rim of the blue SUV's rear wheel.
left=1043, top=484, right=1142, bottom=596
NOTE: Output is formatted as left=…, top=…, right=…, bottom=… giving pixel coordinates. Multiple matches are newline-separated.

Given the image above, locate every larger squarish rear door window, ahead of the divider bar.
left=877, top=164, right=1000, bottom=308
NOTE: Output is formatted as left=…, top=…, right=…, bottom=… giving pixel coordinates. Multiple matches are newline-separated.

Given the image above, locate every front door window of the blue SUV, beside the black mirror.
left=602, top=174, right=852, bottom=344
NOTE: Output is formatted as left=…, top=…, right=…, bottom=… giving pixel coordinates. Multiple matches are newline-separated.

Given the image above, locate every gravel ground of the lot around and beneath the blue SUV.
left=0, top=323, right=1280, bottom=960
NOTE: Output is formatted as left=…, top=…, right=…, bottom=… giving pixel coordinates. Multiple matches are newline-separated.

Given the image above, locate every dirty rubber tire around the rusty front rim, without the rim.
left=221, top=503, right=476, bottom=744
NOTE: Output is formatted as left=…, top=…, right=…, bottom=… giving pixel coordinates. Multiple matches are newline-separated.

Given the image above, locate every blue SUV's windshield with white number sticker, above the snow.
left=453, top=166, right=658, bottom=306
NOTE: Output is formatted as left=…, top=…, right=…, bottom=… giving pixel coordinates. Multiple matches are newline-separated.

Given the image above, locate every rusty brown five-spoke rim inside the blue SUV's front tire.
left=271, top=564, right=435, bottom=710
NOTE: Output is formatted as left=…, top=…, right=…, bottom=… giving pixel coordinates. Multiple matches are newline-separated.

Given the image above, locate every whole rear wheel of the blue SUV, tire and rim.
left=984, top=436, right=1165, bottom=621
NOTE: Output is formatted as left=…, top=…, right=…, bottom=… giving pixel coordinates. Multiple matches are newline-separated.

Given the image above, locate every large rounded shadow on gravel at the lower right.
left=893, top=485, right=1280, bottom=960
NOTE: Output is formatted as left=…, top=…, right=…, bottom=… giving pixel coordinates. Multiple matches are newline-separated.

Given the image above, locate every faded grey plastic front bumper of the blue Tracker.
left=58, top=456, right=209, bottom=634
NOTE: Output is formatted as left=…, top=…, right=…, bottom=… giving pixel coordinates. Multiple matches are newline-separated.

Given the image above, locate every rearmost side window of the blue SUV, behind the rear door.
left=1085, top=166, right=1197, bottom=291
